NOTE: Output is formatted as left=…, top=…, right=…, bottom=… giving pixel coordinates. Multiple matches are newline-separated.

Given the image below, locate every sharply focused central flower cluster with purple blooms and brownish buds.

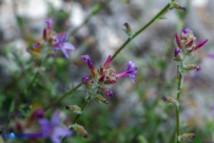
left=82, top=55, right=138, bottom=99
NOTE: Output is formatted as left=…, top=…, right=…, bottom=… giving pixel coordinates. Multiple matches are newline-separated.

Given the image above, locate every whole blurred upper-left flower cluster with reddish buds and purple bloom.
left=28, top=18, right=75, bottom=58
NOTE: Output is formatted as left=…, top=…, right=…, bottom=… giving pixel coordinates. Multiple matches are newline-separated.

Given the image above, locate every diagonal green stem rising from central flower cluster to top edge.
left=111, top=1, right=172, bottom=60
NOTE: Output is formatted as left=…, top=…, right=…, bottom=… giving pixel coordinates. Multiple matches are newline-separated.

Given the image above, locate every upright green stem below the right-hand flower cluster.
left=176, top=64, right=183, bottom=143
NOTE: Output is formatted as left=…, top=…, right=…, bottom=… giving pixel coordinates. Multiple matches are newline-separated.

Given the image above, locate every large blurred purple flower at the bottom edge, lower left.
left=39, top=111, right=71, bottom=143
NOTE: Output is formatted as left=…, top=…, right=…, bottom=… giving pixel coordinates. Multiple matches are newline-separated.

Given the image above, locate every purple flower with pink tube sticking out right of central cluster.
left=117, top=61, right=138, bottom=83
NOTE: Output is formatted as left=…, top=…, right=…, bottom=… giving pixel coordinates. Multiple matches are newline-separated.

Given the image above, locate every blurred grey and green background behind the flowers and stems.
left=0, top=0, right=214, bottom=143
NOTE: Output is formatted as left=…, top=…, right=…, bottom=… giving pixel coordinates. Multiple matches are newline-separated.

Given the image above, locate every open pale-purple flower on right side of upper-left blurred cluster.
left=53, top=33, right=75, bottom=58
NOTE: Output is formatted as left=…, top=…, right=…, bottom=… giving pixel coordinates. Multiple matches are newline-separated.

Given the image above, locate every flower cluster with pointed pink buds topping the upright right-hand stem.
left=174, top=28, right=208, bottom=71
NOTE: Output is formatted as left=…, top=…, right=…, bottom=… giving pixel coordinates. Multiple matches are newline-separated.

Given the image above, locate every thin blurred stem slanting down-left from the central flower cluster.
left=44, top=83, right=82, bottom=111
